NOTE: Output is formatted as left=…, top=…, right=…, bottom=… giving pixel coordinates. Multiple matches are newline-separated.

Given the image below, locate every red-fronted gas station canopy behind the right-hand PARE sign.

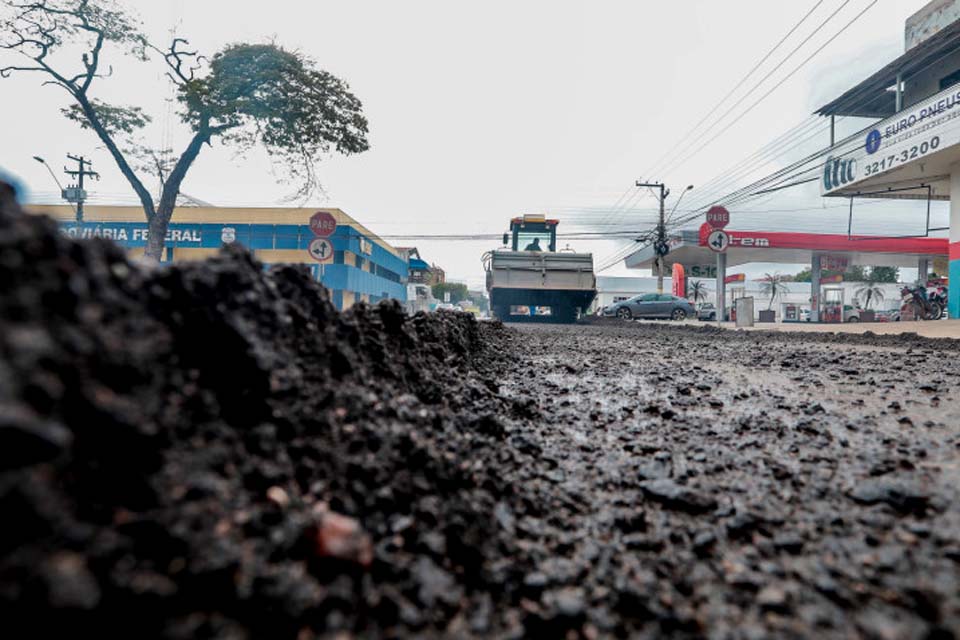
left=624, top=225, right=948, bottom=269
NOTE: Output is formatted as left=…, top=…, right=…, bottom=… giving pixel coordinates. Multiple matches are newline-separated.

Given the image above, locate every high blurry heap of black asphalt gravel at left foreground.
left=0, top=184, right=524, bottom=638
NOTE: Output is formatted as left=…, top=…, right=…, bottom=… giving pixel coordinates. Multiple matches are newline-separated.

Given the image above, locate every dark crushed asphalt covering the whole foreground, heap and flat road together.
left=0, top=185, right=960, bottom=640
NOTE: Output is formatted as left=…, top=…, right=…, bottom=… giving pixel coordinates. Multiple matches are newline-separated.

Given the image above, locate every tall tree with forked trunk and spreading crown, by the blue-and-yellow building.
left=0, top=0, right=369, bottom=259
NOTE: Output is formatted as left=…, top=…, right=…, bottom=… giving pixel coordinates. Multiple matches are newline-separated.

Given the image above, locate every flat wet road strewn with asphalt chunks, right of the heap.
left=488, top=323, right=960, bottom=638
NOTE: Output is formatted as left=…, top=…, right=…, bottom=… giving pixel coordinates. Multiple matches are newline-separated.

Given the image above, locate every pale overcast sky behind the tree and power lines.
left=0, top=0, right=945, bottom=284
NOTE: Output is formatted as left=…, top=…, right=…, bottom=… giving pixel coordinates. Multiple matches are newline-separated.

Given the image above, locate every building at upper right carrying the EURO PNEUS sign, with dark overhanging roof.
left=817, top=0, right=960, bottom=317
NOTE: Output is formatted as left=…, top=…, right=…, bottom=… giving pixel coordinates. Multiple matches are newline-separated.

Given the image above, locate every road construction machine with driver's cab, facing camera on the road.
left=483, top=215, right=597, bottom=323
